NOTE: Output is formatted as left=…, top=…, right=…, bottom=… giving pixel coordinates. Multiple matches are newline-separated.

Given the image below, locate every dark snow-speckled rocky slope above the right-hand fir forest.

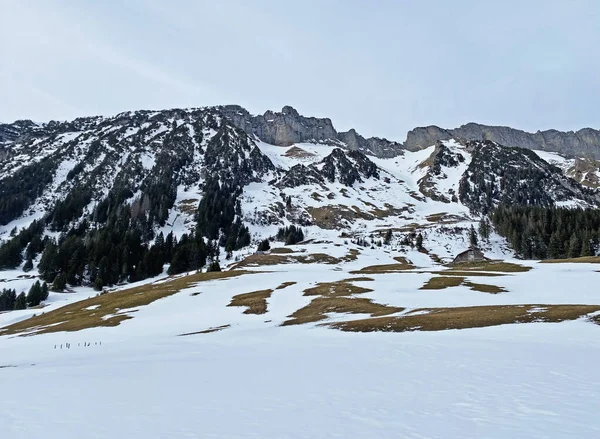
left=459, top=140, right=599, bottom=213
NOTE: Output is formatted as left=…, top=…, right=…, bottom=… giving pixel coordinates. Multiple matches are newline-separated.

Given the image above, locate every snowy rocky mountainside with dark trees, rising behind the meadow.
left=0, top=107, right=598, bottom=296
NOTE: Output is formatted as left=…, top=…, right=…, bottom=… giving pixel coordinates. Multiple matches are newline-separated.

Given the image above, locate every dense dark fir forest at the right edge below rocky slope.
left=492, top=205, right=600, bottom=259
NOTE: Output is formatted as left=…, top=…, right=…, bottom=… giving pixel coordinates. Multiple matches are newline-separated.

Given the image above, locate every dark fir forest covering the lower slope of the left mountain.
left=0, top=176, right=255, bottom=294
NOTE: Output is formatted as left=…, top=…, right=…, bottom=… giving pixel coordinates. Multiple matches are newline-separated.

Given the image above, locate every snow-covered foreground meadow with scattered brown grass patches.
left=0, top=243, right=600, bottom=439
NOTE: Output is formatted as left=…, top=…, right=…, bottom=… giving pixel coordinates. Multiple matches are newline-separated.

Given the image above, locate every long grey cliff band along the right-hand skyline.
left=404, top=123, right=600, bottom=159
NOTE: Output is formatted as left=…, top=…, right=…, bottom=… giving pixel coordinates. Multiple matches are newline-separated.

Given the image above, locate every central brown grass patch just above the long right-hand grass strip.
left=282, top=297, right=404, bottom=326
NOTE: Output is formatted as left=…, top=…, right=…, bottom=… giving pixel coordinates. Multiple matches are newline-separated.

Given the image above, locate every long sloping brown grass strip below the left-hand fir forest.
left=0, top=270, right=250, bottom=335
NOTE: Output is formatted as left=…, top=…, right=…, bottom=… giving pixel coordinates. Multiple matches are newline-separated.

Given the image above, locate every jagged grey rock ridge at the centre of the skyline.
left=217, top=105, right=402, bottom=157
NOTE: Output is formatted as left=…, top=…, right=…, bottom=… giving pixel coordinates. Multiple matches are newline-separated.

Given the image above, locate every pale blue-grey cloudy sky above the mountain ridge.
left=0, top=0, right=600, bottom=141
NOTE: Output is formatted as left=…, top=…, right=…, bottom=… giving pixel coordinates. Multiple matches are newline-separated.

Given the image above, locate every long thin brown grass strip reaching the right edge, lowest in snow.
left=328, top=305, right=600, bottom=332
